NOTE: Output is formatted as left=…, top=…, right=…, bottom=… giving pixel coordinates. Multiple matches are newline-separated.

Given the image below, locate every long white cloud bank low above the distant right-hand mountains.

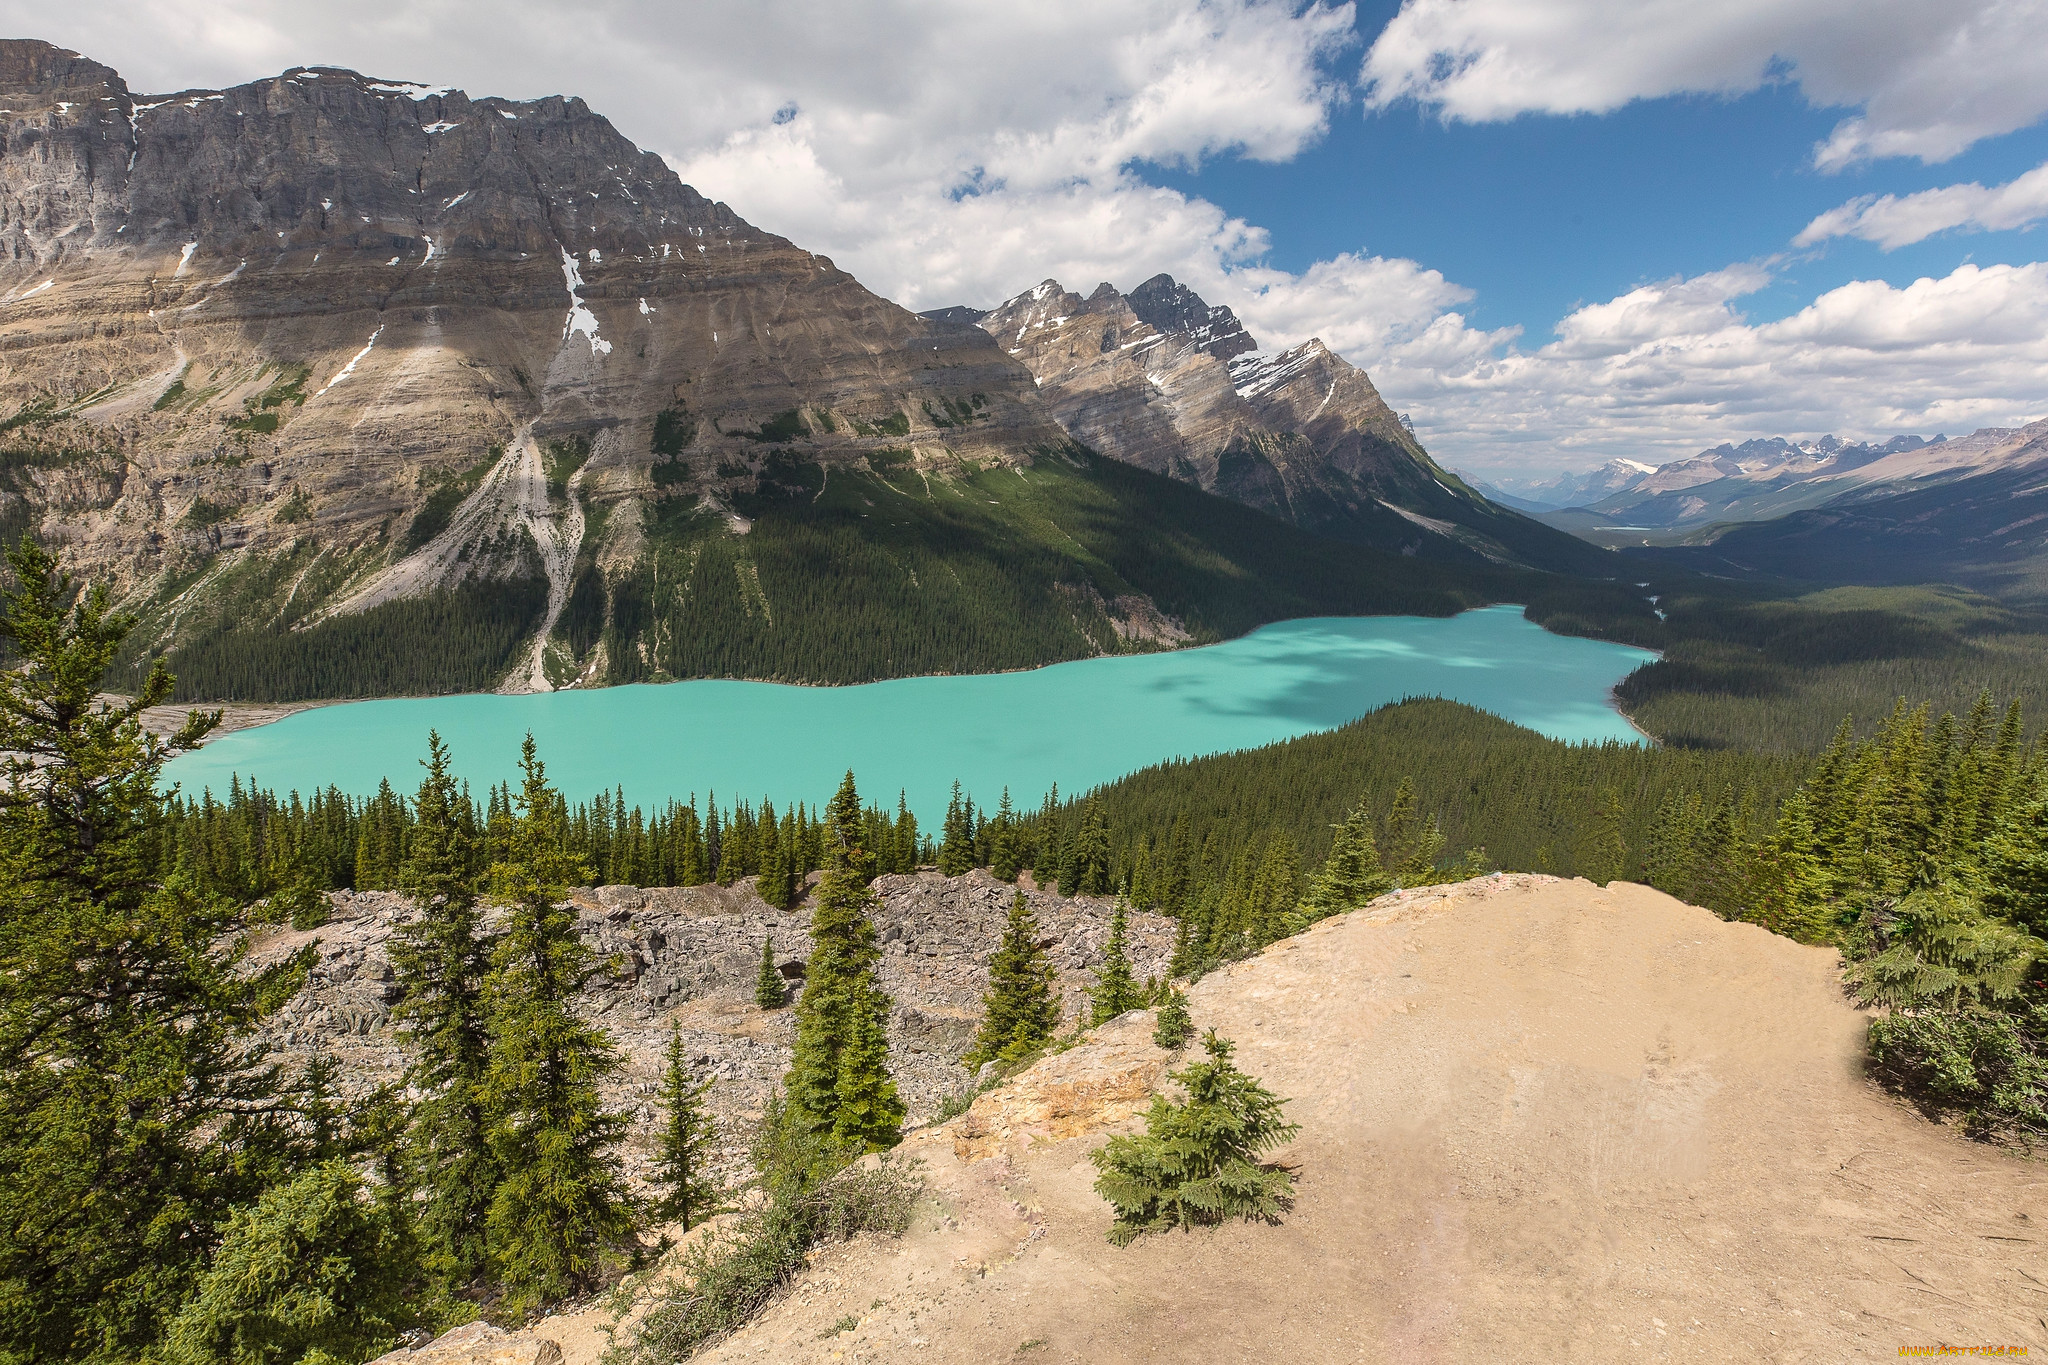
left=1354, top=264, right=2048, bottom=471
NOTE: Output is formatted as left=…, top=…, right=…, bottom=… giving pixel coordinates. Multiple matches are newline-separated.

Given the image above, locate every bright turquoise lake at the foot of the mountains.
left=166, top=606, right=1655, bottom=825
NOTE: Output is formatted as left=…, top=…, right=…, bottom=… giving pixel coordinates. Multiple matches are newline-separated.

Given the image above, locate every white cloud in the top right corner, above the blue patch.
left=1364, top=0, right=2048, bottom=168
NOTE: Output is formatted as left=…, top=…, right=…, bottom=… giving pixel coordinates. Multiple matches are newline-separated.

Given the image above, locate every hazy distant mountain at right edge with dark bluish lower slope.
left=1636, top=422, right=2048, bottom=602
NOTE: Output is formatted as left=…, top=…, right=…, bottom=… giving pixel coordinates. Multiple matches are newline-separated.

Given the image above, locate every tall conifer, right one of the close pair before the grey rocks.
left=483, top=735, right=633, bottom=1308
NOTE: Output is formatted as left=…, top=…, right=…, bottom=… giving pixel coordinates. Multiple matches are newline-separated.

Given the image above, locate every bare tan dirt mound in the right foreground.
left=573, top=878, right=2048, bottom=1365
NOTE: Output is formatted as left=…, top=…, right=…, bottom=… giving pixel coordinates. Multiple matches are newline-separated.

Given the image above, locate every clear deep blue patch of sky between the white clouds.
left=1143, top=72, right=2048, bottom=338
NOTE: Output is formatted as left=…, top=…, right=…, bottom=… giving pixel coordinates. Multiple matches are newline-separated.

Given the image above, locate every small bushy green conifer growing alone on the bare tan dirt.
left=1090, top=1029, right=1300, bottom=1246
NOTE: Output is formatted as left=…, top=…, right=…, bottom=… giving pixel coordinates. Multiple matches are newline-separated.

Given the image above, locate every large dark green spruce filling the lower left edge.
left=0, top=538, right=307, bottom=1361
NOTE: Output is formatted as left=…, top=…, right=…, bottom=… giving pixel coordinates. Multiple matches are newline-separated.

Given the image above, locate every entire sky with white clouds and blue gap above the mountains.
left=16, top=0, right=2048, bottom=479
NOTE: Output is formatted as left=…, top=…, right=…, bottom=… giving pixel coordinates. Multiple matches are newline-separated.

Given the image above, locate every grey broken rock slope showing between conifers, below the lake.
left=254, top=872, right=1174, bottom=1175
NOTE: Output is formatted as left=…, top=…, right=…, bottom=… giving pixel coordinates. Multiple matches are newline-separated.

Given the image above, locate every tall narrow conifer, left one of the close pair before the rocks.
left=389, top=731, right=498, bottom=1283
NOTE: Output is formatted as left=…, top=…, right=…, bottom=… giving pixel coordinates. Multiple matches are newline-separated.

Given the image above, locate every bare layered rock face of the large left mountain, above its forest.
left=0, top=41, right=1063, bottom=686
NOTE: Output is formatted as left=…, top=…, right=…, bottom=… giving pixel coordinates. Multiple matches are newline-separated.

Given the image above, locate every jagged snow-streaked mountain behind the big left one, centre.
left=926, top=274, right=1597, bottom=571
